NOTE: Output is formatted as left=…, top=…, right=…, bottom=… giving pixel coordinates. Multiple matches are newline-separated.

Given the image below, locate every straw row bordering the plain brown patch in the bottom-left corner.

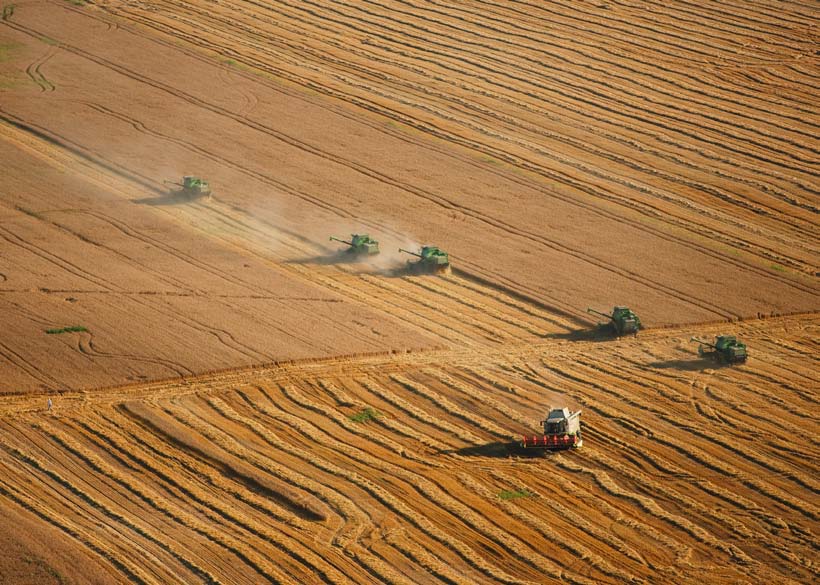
left=0, top=474, right=160, bottom=585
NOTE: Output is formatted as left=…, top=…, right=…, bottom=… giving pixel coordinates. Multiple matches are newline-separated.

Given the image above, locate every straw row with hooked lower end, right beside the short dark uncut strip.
left=164, top=396, right=372, bottom=548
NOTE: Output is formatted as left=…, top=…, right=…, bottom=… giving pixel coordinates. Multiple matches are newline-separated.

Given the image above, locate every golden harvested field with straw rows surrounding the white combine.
left=0, top=317, right=818, bottom=584
